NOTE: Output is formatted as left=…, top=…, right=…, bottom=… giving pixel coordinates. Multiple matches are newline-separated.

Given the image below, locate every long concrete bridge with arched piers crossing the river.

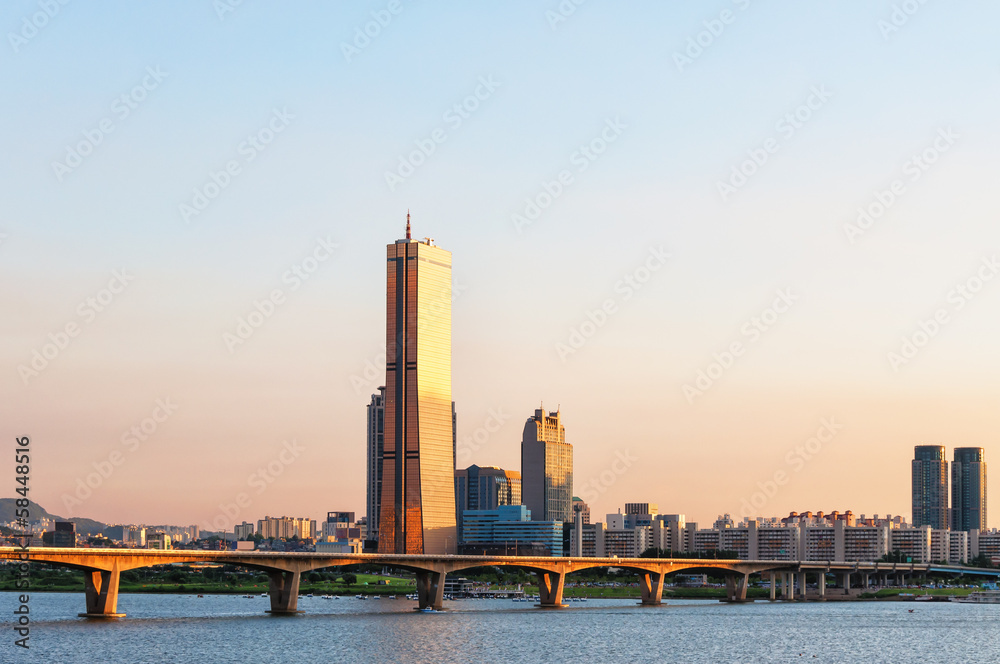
left=0, top=547, right=1000, bottom=618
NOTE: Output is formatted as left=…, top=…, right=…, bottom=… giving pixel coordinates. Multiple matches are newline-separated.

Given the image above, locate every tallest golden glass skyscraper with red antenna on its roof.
left=378, top=213, right=457, bottom=554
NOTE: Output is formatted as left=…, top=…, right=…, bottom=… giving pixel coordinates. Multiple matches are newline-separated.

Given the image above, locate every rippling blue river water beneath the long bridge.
left=0, top=592, right=1000, bottom=664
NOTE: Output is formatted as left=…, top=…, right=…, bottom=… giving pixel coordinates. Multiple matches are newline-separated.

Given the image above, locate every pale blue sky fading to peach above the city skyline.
left=0, top=0, right=1000, bottom=529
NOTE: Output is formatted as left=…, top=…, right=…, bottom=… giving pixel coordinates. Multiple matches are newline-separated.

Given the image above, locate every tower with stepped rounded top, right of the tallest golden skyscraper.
left=521, top=409, right=573, bottom=523
